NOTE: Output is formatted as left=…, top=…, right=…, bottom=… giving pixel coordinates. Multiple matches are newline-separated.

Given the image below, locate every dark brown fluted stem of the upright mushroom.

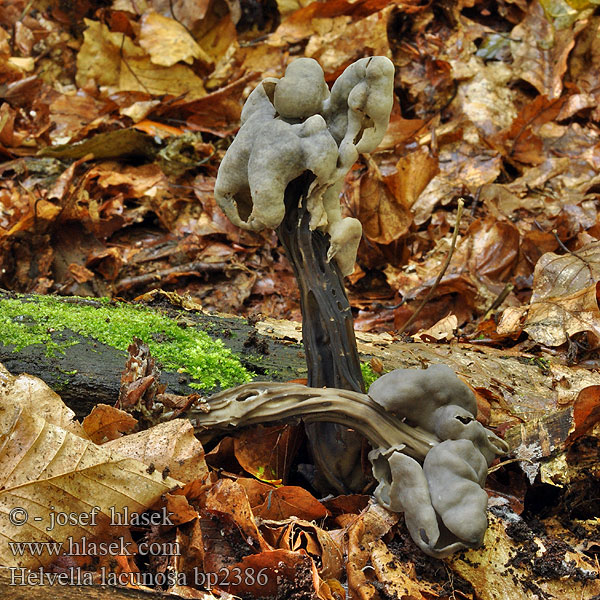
left=277, top=171, right=368, bottom=493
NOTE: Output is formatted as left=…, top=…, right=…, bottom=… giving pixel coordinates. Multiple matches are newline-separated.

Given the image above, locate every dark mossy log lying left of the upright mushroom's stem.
left=0, top=291, right=306, bottom=416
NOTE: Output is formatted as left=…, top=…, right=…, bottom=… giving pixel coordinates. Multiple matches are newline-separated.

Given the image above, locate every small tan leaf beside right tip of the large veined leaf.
left=103, top=419, right=208, bottom=483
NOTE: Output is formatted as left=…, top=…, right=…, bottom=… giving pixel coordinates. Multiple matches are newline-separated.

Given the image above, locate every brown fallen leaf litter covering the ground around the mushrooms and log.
left=0, top=0, right=600, bottom=598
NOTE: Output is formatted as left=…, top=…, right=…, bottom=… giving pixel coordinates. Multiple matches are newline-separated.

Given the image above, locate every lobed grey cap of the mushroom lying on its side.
left=369, top=365, right=508, bottom=557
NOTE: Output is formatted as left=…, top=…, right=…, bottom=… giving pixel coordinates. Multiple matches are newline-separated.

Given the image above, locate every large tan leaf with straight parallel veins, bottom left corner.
left=0, top=370, right=178, bottom=568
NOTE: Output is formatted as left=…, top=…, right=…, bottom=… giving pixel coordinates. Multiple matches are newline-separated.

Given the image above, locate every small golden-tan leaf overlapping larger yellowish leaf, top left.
left=139, top=11, right=212, bottom=67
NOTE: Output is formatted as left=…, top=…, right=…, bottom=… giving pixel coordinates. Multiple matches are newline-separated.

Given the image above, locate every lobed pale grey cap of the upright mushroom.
left=215, top=56, right=394, bottom=275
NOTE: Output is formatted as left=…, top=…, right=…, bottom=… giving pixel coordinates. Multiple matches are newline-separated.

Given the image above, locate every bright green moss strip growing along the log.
left=0, top=296, right=252, bottom=389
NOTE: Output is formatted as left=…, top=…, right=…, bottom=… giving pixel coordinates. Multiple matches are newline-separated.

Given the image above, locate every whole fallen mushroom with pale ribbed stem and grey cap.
left=187, top=365, right=508, bottom=557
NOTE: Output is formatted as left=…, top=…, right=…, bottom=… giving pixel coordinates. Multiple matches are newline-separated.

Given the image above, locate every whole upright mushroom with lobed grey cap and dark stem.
left=215, top=56, right=394, bottom=493
